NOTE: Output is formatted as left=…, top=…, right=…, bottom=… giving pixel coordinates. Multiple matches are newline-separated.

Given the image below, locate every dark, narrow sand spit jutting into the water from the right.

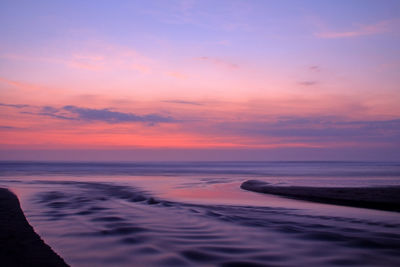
left=240, top=180, right=400, bottom=212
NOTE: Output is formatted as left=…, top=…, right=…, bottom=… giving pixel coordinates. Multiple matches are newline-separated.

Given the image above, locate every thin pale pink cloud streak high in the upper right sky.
left=315, top=20, right=398, bottom=39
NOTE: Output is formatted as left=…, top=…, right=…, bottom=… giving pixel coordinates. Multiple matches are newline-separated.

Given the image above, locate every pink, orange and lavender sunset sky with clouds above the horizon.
left=0, top=0, right=400, bottom=161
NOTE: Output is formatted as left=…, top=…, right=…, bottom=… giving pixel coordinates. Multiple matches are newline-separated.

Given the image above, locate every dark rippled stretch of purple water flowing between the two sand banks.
left=23, top=183, right=400, bottom=266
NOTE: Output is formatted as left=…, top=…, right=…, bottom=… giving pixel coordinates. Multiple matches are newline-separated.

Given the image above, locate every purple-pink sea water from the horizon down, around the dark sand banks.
left=0, top=162, right=400, bottom=266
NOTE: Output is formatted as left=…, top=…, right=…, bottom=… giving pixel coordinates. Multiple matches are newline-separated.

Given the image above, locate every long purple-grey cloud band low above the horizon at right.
left=209, top=116, right=400, bottom=144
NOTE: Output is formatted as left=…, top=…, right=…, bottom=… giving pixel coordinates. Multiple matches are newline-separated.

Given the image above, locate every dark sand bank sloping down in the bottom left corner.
left=0, top=188, right=68, bottom=266
